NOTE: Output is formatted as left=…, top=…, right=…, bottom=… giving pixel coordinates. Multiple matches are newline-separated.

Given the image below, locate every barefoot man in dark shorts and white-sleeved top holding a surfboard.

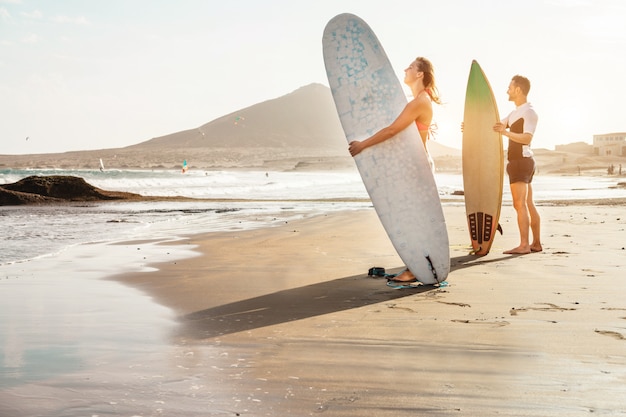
left=493, top=75, right=543, bottom=255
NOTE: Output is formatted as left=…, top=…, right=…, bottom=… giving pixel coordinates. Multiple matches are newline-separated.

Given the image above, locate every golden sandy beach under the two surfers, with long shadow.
left=0, top=202, right=626, bottom=417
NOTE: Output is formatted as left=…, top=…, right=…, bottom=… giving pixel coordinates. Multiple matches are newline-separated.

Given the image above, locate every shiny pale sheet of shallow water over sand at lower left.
left=0, top=236, right=234, bottom=417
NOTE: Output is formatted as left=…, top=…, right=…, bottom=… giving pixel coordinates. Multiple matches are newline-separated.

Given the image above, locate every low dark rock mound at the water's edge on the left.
left=0, top=175, right=141, bottom=206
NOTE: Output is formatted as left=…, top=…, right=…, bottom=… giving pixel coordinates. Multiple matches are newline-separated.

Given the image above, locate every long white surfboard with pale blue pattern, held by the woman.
left=323, top=14, right=450, bottom=284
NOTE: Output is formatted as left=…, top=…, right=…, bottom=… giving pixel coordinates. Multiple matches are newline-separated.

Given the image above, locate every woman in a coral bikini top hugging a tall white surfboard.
left=348, top=57, right=441, bottom=282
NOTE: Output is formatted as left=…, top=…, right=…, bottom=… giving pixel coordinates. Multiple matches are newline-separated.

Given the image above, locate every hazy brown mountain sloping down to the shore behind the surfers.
left=0, top=84, right=460, bottom=169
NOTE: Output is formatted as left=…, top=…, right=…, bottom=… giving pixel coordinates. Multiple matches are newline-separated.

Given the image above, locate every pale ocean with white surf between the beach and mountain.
left=0, top=169, right=626, bottom=265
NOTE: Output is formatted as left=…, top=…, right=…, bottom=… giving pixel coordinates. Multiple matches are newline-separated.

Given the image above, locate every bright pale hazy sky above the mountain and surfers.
left=0, top=0, right=626, bottom=154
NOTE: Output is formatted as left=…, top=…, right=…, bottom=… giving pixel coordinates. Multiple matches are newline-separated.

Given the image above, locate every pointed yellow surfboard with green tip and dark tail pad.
left=463, top=60, right=504, bottom=256
